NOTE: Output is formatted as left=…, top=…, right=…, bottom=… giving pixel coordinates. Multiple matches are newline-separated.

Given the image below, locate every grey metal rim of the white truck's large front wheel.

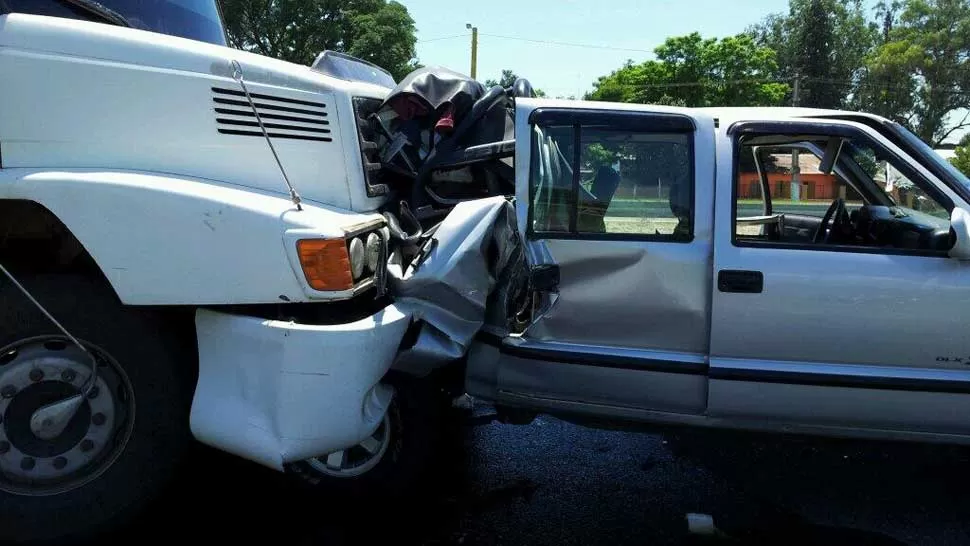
left=0, top=336, right=135, bottom=496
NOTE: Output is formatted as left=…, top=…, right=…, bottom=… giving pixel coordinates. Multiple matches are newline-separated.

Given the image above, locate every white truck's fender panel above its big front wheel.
left=0, top=169, right=382, bottom=305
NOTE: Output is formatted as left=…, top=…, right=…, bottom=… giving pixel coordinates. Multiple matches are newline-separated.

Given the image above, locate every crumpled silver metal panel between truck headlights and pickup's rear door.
left=388, top=197, right=520, bottom=375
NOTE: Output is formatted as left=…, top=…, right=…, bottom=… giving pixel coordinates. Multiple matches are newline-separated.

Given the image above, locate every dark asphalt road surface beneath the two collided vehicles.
left=109, top=402, right=970, bottom=546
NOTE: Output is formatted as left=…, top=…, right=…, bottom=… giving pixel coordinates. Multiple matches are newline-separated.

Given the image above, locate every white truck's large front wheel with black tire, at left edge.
left=0, top=275, right=191, bottom=544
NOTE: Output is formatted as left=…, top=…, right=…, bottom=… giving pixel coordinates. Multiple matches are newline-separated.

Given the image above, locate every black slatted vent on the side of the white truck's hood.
left=212, top=87, right=333, bottom=142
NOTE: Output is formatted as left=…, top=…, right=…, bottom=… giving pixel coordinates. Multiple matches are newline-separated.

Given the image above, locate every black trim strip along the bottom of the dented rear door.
left=476, top=332, right=708, bottom=375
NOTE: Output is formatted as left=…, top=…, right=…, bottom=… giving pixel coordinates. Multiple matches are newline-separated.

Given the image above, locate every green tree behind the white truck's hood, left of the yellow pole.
left=222, top=0, right=417, bottom=79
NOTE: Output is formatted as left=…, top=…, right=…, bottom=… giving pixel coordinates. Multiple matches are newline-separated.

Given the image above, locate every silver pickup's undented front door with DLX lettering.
left=708, top=120, right=970, bottom=433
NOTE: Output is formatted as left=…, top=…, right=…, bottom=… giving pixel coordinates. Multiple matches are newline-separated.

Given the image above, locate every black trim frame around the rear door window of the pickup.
left=526, top=108, right=697, bottom=244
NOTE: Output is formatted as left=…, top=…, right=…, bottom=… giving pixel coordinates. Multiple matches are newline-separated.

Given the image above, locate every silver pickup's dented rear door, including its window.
left=469, top=104, right=714, bottom=418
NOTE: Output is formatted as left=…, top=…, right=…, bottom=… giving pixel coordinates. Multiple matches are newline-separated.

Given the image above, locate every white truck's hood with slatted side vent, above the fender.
left=0, top=14, right=388, bottom=212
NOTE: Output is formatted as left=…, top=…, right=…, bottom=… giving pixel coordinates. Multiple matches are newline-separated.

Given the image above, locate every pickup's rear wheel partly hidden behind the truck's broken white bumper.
left=287, top=379, right=443, bottom=501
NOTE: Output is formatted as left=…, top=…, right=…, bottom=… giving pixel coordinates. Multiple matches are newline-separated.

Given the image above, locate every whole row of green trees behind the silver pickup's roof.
left=586, top=0, right=970, bottom=146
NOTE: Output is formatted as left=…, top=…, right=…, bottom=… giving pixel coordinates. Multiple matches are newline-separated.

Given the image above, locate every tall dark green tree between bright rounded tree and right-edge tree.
left=748, top=0, right=878, bottom=108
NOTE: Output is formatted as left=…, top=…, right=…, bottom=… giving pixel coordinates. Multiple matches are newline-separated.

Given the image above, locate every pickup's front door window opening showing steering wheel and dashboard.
left=734, top=135, right=954, bottom=252
